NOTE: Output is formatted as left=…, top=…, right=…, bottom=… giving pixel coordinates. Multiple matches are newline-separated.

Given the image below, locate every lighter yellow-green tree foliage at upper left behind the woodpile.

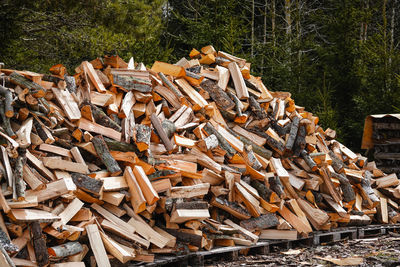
left=0, top=0, right=171, bottom=72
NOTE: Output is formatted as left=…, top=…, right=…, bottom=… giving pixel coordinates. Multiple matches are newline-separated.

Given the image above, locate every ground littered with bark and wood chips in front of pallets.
left=205, top=232, right=400, bottom=267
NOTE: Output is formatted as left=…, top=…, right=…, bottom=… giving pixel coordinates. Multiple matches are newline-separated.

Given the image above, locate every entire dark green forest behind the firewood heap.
left=0, top=0, right=400, bottom=151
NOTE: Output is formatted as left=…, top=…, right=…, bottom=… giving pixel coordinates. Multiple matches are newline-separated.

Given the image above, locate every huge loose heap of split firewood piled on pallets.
left=0, top=46, right=400, bottom=267
